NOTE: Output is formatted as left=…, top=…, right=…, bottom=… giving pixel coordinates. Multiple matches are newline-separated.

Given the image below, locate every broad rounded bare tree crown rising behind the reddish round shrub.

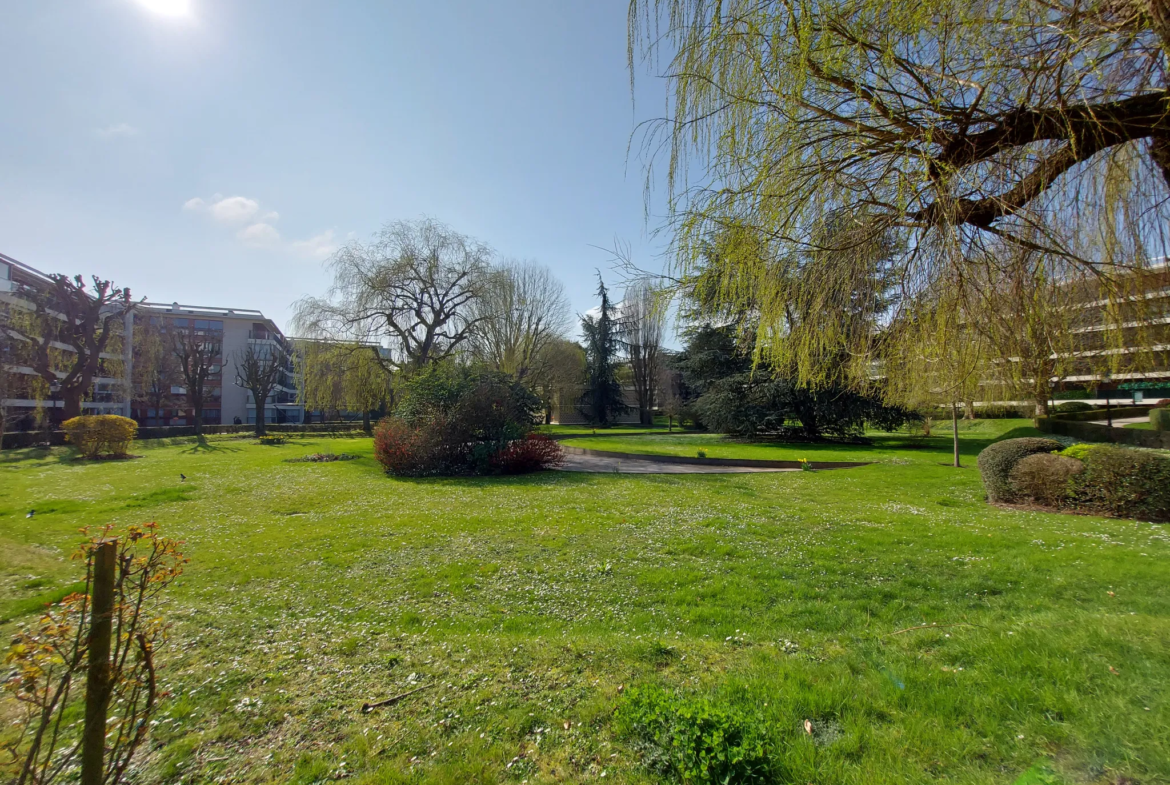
left=294, top=220, right=491, bottom=372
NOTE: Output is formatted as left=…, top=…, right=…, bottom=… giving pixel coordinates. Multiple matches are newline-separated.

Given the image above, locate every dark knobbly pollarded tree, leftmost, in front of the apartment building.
left=8, top=274, right=137, bottom=420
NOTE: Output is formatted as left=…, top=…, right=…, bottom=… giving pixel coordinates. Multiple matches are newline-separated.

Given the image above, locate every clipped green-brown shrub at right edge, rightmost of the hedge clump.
left=1072, top=445, right=1170, bottom=521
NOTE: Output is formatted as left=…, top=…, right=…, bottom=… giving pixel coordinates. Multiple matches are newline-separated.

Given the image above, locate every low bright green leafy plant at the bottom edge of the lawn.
left=615, top=687, right=779, bottom=784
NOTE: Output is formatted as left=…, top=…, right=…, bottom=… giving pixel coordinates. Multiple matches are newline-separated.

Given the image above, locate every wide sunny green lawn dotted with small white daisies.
left=0, top=430, right=1170, bottom=785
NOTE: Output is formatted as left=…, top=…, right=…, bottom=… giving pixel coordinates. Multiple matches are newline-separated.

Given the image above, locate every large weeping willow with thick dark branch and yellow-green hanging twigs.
left=629, top=0, right=1170, bottom=395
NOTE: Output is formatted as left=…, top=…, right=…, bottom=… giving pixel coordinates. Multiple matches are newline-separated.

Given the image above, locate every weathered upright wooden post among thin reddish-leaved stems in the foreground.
left=81, top=539, right=118, bottom=785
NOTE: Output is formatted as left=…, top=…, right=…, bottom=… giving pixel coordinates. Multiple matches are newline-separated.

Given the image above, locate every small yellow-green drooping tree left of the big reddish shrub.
left=294, top=340, right=392, bottom=433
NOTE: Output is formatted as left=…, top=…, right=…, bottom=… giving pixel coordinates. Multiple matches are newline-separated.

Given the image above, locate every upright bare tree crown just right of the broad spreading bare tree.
left=470, top=261, right=572, bottom=381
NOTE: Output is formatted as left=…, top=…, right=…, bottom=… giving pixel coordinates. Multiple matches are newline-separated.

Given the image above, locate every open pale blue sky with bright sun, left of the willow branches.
left=0, top=0, right=663, bottom=334
